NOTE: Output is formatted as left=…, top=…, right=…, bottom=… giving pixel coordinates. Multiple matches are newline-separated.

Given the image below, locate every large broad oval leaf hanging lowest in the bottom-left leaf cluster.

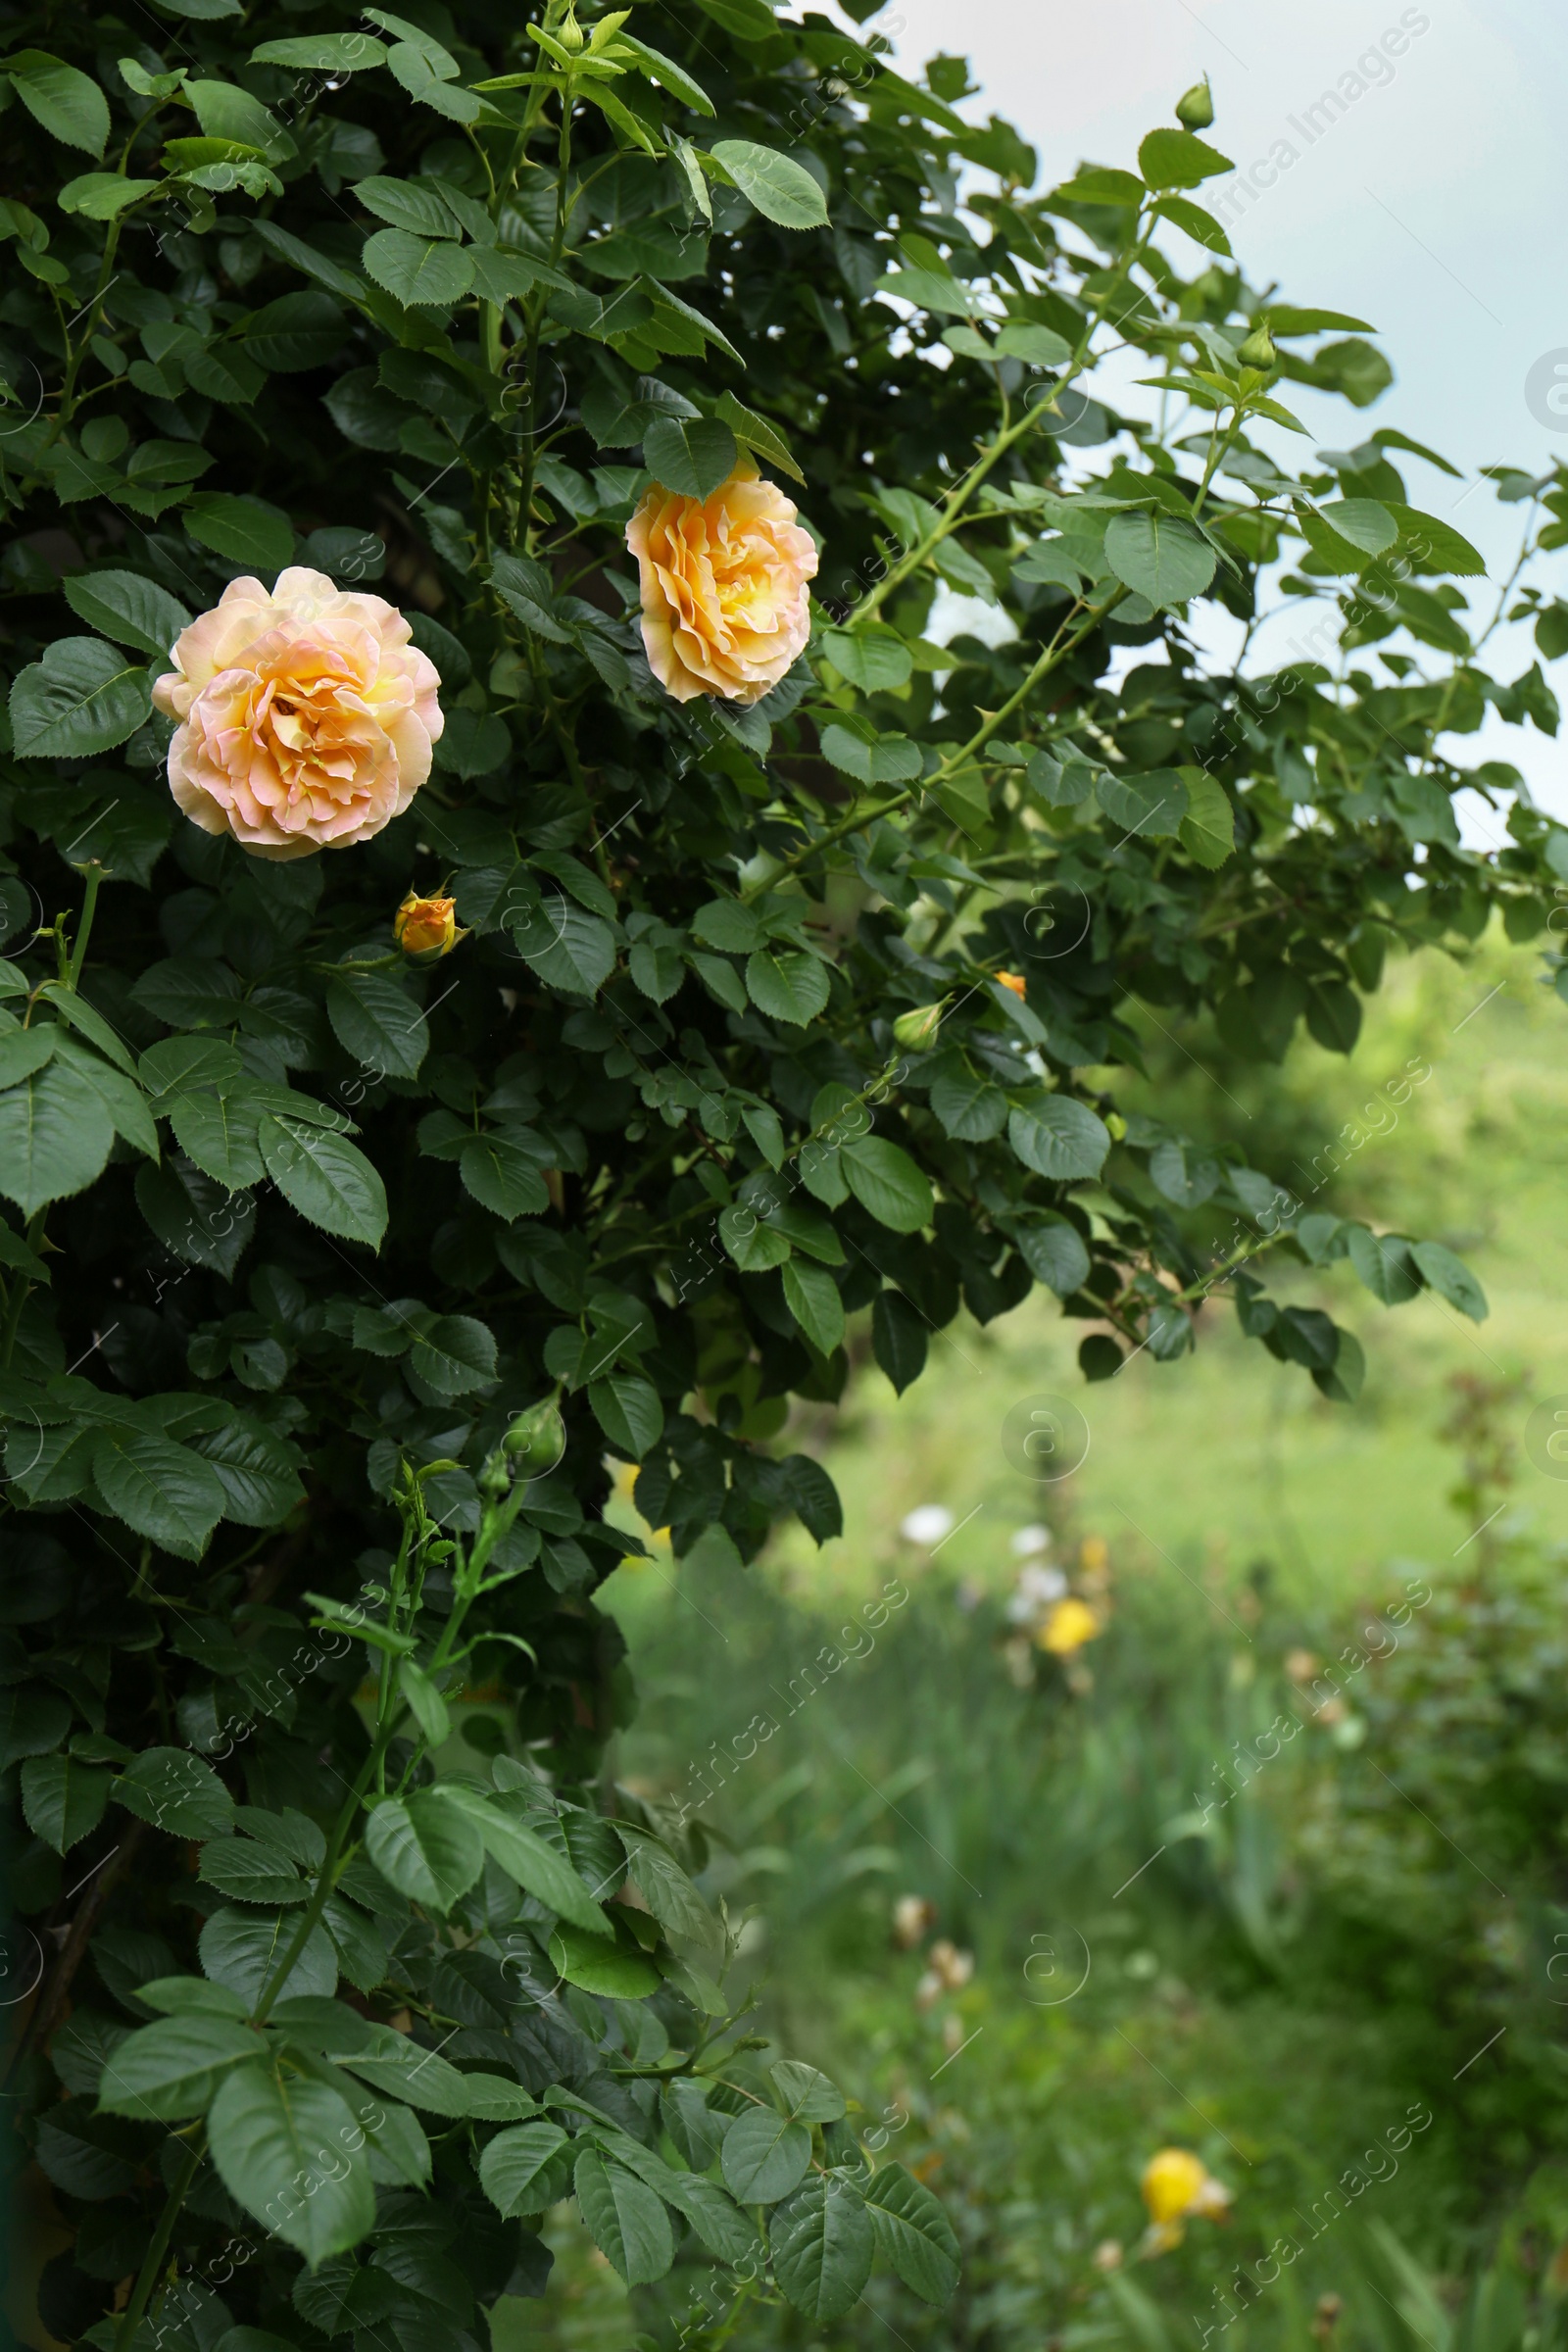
left=207, top=2063, right=376, bottom=2268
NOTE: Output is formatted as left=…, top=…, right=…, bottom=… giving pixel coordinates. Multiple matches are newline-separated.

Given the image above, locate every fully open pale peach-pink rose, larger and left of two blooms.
left=153, top=564, right=444, bottom=858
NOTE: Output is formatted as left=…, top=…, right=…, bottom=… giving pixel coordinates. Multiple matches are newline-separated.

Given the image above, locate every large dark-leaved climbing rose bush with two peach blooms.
left=0, top=0, right=1568, bottom=2352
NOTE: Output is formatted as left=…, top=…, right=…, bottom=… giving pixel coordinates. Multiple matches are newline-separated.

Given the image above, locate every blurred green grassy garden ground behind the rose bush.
left=562, top=941, right=1568, bottom=2352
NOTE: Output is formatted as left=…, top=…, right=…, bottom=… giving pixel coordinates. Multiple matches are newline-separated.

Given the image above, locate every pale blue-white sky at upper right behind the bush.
left=822, top=0, right=1568, bottom=827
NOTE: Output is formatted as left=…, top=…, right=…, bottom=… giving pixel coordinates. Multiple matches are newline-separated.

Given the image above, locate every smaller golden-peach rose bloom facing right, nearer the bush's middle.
left=625, top=461, right=815, bottom=704
